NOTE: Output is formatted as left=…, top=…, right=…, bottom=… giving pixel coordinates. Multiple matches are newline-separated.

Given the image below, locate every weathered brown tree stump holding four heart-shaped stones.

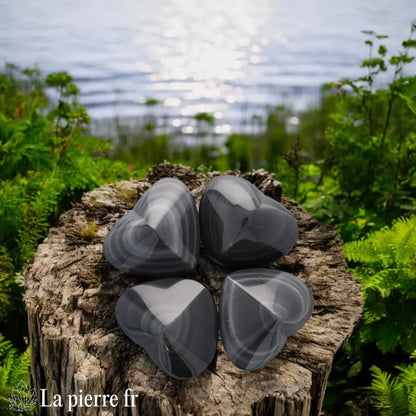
left=25, top=164, right=362, bottom=416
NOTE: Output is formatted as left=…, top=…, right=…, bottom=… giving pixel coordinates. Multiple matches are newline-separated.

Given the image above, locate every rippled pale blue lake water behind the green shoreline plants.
left=0, top=0, right=416, bottom=134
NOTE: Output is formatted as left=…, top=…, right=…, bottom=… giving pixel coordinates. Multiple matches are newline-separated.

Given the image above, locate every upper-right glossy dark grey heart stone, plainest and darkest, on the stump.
left=199, top=175, right=298, bottom=268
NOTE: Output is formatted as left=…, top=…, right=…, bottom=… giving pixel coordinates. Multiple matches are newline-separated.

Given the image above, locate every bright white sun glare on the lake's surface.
left=136, top=0, right=271, bottom=116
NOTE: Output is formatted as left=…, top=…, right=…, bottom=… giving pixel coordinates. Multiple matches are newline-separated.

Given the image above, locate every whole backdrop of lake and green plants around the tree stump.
left=0, top=0, right=416, bottom=416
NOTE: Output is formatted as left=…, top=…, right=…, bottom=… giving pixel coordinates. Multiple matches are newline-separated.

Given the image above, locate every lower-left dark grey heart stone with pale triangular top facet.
left=116, top=278, right=218, bottom=380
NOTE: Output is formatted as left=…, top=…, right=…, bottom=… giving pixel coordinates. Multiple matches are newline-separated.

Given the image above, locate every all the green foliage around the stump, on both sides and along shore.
left=0, top=25, right=416, bottom=415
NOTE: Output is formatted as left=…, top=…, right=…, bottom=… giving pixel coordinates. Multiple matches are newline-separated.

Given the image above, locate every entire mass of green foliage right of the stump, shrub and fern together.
left=299, top=25, right=416, bottom=415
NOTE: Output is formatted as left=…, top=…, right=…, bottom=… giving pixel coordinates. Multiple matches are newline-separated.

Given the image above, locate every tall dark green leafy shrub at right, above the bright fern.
left=304, top=25, right=416, bottom=240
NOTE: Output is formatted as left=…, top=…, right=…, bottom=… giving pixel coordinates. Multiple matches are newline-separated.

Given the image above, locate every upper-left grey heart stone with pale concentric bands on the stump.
left=103, top=178, right=199, bottom=277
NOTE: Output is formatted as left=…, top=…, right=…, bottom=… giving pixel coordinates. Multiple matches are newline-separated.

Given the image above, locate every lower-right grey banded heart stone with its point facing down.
left=219, top=269, right=313, bottom=371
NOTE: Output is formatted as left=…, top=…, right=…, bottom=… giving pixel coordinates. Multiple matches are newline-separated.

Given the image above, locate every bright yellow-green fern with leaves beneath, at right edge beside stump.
left=344, top=216, right=416, bottom=353
